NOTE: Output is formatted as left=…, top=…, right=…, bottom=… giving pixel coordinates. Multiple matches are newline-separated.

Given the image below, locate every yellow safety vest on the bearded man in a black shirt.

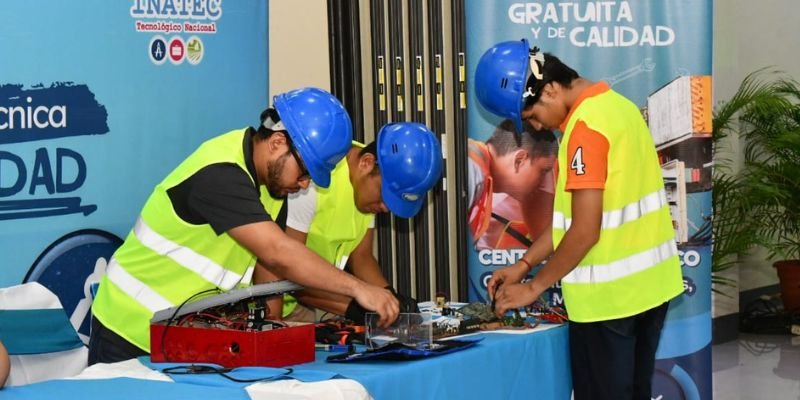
left=92, top=129, right=283, bottom=351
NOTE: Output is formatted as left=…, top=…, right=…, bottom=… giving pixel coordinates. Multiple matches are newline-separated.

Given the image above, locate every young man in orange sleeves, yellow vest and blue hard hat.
left=475, top=39, right=683, bottom=400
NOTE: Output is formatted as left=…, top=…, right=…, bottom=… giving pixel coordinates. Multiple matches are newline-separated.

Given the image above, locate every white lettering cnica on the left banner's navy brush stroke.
left=0, top=96, right=67, bottom=130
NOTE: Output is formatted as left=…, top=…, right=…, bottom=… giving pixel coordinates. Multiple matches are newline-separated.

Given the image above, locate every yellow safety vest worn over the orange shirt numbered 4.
left=553, top=90, right=683, bottom=322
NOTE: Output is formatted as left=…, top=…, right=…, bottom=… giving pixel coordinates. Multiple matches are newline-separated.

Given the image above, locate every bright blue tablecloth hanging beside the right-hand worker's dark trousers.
left=295, top=326, right=572, bottom=400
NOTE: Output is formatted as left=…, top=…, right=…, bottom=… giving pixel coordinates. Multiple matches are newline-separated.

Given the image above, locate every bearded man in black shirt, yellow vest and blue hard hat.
left=89, top=88, right=399, bottom=364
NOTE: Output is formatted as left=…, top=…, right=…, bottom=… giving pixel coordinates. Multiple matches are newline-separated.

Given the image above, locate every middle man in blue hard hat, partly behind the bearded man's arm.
left=256, top=122, right=442, bottom=325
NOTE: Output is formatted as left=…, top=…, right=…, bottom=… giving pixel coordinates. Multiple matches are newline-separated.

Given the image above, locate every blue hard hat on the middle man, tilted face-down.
left=378, top=122, right=442, bottom=218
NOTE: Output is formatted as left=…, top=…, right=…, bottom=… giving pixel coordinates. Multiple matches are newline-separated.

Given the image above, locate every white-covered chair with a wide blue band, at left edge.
left=0, top=282, right=88, bottom=386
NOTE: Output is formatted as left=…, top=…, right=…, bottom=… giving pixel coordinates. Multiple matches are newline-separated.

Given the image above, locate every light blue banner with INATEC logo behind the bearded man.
left=0, top=0, right=268, bottom=339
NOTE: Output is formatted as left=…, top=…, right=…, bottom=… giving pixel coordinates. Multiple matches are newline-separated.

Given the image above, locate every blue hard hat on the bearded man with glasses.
left=272, top=87, right=353, bottom=188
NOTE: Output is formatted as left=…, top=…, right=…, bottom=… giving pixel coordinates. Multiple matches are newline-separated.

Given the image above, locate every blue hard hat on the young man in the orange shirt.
left=475, top=39, right=530, bottom=133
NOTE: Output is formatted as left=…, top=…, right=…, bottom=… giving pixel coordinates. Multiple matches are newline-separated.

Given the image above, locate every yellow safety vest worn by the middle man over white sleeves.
left=283, top=141, right=375, bottom=317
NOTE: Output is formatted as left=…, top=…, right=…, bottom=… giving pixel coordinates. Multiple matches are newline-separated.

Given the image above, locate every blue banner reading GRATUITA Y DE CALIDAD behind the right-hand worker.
left=465, top=0, right=713, bottom=399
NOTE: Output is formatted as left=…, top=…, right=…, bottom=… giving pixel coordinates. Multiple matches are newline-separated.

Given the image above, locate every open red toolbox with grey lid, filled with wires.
left=150, top=281, right=314, bottom=368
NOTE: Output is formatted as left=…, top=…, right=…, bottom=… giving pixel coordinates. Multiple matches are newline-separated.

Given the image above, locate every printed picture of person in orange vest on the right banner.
left=467, top=119, right=558, bottom=249
